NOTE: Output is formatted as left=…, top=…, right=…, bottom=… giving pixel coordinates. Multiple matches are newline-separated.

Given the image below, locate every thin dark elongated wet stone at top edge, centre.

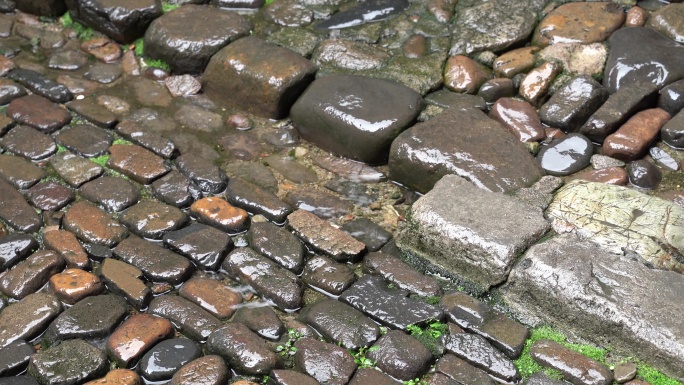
left=316, top=0, right=409, bottom=29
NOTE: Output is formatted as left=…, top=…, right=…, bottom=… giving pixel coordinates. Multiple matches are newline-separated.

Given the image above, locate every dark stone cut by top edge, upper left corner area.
left=66, top=0, right=162, bottom=44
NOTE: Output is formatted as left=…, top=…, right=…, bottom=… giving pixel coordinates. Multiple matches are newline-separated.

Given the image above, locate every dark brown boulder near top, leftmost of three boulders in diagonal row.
left=144, top=5, right=252, bottom=74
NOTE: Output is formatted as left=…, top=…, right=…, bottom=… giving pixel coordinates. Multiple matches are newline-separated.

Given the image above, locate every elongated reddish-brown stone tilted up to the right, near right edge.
left=603, top=108, right=671, bottom=162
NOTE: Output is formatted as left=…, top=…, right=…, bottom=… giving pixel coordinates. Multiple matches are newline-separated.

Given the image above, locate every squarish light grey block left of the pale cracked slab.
left=397, top=175, right=550, bottom=290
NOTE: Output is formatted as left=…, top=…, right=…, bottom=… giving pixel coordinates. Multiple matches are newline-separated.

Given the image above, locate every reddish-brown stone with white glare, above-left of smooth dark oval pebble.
left=489, top=98, right=546, bottom=142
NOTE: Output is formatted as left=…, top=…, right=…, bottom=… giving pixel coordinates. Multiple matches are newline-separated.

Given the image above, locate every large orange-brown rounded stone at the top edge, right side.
left=532, top=2, right=625, bottom=47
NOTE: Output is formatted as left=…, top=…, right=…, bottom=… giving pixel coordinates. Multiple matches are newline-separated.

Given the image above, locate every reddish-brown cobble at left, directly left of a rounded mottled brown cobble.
left=64, top=201, right=128, bottom=247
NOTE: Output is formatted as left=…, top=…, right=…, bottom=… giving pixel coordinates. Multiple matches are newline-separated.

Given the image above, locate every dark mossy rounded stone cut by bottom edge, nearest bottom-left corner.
left=29, top=340, right=109, bottom=384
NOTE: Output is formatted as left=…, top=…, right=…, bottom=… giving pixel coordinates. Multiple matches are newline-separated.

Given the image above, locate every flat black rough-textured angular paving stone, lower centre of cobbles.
left=339, top=275, right=443, bottom=330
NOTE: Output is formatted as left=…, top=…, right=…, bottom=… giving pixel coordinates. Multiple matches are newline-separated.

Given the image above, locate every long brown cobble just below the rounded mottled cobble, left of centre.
left=113, top=235, right=194, bottom=285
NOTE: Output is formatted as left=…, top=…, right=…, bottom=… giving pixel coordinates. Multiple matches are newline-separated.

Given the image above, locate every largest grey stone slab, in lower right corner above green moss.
left=502, top=234, right=684, bottom=381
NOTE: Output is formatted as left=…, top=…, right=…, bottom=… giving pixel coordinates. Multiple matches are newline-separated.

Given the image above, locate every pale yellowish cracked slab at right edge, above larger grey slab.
left=546, top=180, right=684, bottom=273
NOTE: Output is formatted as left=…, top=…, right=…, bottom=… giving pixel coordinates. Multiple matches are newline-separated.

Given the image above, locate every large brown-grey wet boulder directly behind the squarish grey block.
left=389, top=107, right=543, bottom=193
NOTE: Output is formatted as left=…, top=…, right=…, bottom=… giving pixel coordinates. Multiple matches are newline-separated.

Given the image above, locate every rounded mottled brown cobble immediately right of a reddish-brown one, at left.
left=121, top=200, right=188, bottom=239
